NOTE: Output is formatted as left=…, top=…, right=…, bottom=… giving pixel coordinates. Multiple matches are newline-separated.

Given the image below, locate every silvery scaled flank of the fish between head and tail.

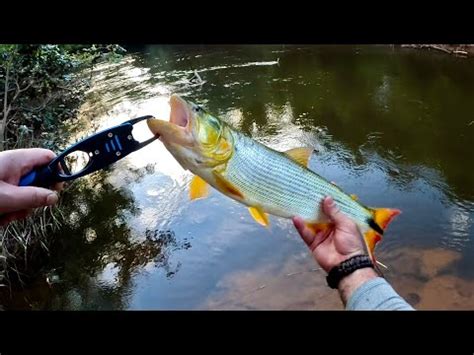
left=224, top=131, right=371, bottom=224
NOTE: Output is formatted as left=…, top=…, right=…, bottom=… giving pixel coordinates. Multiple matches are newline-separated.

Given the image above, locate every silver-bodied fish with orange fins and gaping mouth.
left=147, top=94, right=401, bottom=263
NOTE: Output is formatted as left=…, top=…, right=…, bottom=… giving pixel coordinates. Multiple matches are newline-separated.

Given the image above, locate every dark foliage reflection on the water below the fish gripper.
left=3, top=169, right=190, bottom=309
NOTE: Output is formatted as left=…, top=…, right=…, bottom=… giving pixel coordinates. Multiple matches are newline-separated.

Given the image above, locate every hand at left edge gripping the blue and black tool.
left=0, top=148, right=63, bottom=225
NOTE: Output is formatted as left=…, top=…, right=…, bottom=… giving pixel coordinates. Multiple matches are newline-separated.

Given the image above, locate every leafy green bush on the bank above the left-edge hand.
left=0, top=44, right=124, bottom=150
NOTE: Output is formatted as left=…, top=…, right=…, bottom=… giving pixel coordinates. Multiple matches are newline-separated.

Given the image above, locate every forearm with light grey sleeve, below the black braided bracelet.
left=339, top=268, right=413, bottom=310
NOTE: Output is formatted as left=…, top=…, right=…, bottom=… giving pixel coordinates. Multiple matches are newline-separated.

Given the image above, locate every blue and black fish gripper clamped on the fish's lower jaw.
left=19, top=116, right=158, bottom=187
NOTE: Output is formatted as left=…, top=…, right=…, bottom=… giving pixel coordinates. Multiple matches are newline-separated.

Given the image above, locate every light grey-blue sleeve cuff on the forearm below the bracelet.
left=346, top=277, right=414, bottom=311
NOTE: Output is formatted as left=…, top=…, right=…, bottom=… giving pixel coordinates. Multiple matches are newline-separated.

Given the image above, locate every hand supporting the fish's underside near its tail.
left=293, top=196, right=366, bottom=272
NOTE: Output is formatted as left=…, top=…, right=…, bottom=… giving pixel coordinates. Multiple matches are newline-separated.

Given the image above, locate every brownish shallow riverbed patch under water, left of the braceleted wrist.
left=199, top=253, right=343, bottom=310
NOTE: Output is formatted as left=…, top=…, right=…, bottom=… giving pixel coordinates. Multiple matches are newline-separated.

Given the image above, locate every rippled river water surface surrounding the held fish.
left=1, top=45, right=474, bottom=309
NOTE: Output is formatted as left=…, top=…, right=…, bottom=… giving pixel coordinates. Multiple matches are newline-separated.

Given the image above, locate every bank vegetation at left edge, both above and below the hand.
left=0, top=44, right=125, bottom=285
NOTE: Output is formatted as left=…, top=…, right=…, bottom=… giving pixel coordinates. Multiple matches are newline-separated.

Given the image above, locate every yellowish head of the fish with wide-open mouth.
left=147, top=94, right=234, bottom=171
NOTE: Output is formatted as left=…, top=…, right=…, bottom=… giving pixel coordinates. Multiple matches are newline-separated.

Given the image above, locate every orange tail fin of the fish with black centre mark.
left=364, top=208, right=401, bottom=265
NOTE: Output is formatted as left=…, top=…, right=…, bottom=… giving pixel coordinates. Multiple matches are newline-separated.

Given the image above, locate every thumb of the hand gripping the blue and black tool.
left=0, top=183, right=58, bottom=212
